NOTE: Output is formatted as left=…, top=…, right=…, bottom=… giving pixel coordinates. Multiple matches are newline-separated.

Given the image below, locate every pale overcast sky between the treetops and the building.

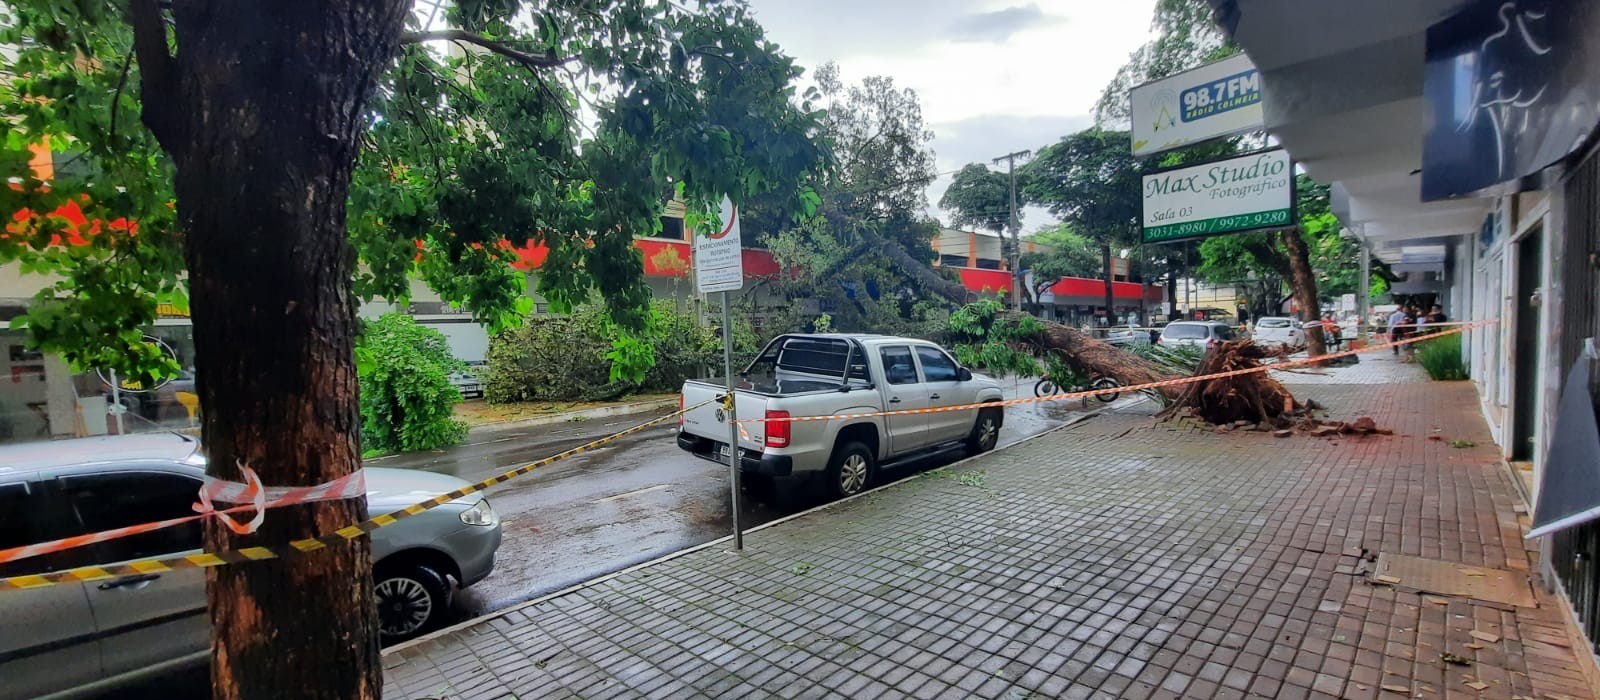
left=749, top=0, right=1155, bottom=232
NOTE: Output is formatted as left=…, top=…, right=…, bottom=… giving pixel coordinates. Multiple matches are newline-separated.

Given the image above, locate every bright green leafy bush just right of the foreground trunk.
left=357, top=313, right=467, bottom=452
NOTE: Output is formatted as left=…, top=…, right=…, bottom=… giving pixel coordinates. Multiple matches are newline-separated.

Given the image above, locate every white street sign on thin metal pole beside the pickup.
left=694, top=197, right=744, bottom=551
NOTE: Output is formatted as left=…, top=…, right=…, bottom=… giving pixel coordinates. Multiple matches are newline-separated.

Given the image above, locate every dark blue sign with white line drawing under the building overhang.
left=1422, top=0, right=1600, bottom=201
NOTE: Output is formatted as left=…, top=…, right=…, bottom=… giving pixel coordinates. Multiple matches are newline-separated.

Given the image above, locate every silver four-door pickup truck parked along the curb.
left=678, top=334, right=1005, bottom=495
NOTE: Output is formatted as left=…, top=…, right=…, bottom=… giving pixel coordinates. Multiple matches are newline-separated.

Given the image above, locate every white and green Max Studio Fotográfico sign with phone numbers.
left=1142, top=149, right=1294, bottom=243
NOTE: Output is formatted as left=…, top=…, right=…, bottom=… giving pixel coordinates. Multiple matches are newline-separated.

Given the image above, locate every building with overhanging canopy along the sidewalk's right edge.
left=1210, top=0, right=1600, bottom=650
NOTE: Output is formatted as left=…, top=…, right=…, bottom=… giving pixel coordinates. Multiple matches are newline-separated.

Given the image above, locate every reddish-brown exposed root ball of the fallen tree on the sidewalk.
left=1160, top=340, right=1394, bottom=436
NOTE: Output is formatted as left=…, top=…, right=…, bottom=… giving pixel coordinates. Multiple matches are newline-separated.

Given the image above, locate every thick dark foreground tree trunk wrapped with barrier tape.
left=131, top=0, right=410, bottom=700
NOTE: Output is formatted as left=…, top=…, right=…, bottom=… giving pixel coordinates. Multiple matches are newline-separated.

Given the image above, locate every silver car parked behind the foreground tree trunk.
left=0, top=433, right=501, bottom=700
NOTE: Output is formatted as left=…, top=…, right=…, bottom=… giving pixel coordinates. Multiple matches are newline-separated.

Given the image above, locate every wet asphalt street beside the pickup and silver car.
left=366, top=373, right=1102, bottom=622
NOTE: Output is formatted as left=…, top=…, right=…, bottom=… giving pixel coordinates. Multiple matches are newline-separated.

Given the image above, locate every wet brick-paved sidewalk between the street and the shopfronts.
left=384, top=363, right=1592, bottom=700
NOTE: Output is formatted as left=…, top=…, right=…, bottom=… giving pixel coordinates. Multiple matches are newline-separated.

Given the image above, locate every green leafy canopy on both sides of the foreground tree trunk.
left=0, top=0, right=825, bottom=383
